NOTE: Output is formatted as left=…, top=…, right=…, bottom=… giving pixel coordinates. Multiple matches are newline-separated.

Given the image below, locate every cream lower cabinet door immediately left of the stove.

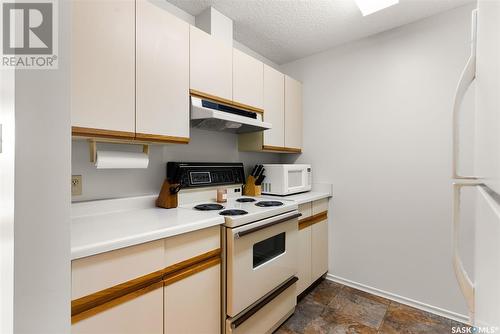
left=164, top=264, right=221, bottom=334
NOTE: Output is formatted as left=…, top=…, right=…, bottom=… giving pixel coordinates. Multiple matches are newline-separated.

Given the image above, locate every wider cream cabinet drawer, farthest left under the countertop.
left=71, top=240, right=164, bottom=300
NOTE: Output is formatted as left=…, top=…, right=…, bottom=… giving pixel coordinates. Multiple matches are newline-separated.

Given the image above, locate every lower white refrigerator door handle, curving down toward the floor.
left=452, top=182, right=482, bottom=323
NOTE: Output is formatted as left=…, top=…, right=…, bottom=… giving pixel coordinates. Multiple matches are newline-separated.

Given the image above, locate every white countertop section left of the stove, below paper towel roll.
left=71, top=196, right=224, bottom=260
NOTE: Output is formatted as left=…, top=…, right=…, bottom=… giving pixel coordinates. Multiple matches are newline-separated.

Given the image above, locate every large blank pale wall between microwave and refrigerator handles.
left=283, top=6, right=473, bottom=314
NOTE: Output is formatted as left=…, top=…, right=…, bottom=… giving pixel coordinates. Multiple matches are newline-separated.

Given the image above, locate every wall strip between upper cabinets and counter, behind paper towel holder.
left=72, top=128, right=280, bottom=201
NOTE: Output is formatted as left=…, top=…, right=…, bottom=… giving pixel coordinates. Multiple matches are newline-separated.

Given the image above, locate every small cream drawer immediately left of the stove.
left=163, top=226, right=221, bottom=267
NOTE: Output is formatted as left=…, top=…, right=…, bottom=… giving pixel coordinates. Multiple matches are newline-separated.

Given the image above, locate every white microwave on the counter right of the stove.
left=262, top=164, right=312, bottom=196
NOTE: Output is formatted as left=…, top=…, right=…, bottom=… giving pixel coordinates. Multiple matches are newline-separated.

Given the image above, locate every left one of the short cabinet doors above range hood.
left=189, top=26, right=233, bottom=101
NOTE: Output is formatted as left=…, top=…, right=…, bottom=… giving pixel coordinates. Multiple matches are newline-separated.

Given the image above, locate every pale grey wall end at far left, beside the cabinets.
left=11, top=1, right=71, bottom=334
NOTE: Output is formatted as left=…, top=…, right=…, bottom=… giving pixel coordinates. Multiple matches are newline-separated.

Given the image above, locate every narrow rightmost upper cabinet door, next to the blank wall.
left=285, top=76, right=303, bottom=149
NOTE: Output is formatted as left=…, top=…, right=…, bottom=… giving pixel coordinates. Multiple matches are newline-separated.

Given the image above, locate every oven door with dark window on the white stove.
left=226, top=210, right=300, bottom=317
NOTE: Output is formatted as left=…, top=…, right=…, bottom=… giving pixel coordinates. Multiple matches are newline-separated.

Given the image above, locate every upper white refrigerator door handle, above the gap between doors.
left=452, top=10, right=478, bottom=180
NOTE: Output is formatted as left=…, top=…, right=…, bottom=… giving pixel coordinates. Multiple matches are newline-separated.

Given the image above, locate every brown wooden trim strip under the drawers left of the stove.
left=71, top=248, right=221, bottom=323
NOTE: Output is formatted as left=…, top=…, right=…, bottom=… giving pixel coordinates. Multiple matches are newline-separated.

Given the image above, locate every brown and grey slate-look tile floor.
left=275, top=280, right=464, bottom=334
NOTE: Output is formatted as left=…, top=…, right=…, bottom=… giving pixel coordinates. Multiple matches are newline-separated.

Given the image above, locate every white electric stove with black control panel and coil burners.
left=167, top=162, right=300, bottom=333
